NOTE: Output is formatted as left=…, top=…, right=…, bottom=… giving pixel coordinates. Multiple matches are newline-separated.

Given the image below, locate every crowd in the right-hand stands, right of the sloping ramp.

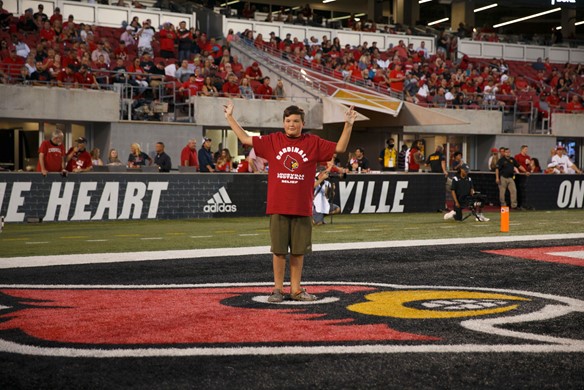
left=242, top=31, right=584, bottom=112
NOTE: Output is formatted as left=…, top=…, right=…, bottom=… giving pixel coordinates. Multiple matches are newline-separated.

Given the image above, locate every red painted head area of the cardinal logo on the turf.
left=0, top=286, right=437, bottom=345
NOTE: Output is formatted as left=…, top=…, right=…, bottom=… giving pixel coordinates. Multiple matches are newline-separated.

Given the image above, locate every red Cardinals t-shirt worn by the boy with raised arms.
left=253, top=133, right=337, bottom=216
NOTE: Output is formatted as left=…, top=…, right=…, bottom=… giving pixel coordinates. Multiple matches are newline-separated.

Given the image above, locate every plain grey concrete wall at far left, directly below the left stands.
left=0, top=84, right=120, bottom=122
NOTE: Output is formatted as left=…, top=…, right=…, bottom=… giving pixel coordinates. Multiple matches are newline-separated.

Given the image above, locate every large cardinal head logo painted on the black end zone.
left=0, top=282, right=584, bottom=357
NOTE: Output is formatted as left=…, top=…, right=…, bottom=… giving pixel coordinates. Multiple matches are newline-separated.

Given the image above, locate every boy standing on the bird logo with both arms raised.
left=224, top=101, right=357, bottom=302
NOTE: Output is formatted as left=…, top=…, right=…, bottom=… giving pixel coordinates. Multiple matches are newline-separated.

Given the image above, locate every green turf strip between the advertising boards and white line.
left=0, top=210, right=584, bottom=257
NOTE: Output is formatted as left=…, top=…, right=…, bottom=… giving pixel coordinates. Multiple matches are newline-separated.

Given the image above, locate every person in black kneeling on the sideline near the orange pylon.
left=444, top=164, right=490, bottom=222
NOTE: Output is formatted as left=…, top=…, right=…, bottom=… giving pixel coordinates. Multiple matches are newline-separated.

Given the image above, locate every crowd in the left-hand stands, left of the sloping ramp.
left=0, top=5, right=286, bottom=100
